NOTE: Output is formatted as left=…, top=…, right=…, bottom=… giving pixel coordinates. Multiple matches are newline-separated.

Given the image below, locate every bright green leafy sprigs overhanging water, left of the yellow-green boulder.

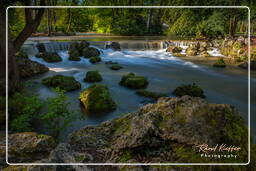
left=40, top=88, right=74, bottom=137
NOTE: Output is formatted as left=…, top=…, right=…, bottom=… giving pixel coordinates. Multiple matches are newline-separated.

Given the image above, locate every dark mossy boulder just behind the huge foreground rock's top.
left=173, top=83, right=205, bottom=98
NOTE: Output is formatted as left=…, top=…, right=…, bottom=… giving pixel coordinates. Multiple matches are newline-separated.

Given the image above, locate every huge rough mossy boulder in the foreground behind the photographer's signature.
left=68, top=96, right=248, bottom=163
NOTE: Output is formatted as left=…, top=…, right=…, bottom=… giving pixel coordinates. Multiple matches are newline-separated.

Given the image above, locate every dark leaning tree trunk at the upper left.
left=0, top=0, right=45, bottom=95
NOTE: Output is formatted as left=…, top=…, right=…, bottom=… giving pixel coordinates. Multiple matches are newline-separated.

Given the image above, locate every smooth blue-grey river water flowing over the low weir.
left=21, top=37, right=256, bottom=141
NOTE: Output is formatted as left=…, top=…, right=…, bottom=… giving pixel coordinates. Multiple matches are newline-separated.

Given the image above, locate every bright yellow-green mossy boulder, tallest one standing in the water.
left=79, top=84, right=116, bottom=113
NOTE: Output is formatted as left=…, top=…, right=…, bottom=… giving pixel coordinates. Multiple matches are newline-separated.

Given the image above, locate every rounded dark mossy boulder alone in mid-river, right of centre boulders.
left=119, top=73, right=148, bottom=89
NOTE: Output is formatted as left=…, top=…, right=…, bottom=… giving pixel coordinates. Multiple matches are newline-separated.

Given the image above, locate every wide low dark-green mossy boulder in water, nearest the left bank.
left=42, top=75, right=81, bottom=91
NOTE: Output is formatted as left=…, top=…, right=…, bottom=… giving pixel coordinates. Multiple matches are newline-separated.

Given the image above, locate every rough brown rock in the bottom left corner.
left=0, top=132, right=57, bottom=163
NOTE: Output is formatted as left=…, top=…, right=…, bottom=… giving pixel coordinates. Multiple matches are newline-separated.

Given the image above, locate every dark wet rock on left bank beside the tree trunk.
left=16, top=58, right=49, bottom=78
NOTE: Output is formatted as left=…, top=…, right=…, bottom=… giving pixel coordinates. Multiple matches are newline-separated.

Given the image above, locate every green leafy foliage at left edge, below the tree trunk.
left=9, top=93, right=42, bottom=132
